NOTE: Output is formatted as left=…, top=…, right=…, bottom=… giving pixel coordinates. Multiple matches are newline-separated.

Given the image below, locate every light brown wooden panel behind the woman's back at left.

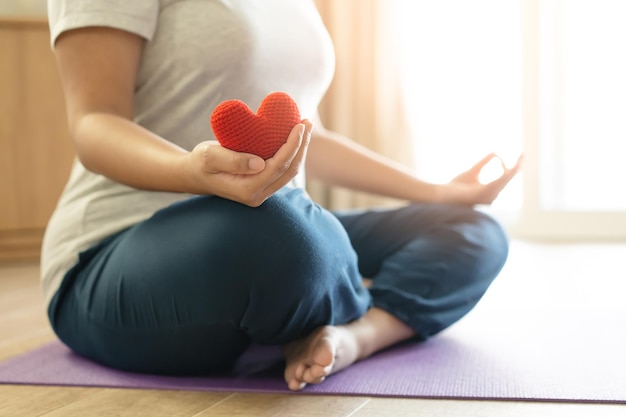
left=0, top=19, right=74, bottom=261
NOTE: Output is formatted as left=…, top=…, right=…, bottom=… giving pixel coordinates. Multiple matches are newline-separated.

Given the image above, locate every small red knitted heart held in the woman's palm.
left=211, top=92, right=300, bottom=159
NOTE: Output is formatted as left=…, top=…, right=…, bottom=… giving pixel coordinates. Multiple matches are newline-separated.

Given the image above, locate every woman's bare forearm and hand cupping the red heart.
left=70, top=112, right=311, bottom=207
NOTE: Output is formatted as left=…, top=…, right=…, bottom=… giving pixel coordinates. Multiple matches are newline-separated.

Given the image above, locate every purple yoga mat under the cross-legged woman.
left=0, top=309, right=626, bottom=403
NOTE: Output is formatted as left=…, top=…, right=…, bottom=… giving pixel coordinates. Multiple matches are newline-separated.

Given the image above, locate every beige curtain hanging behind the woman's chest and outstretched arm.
left=308, top=0, right=413, bottom=209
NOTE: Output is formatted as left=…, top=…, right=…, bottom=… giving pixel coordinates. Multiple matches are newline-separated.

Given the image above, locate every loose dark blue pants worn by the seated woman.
left=48, top=188, right=508, bottom=375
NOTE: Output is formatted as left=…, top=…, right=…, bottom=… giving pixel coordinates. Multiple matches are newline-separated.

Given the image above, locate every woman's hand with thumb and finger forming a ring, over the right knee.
left=441, top=154, right=523, bottom=205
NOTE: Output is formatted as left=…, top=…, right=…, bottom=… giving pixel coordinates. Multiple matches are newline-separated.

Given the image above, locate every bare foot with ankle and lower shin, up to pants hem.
left=284, top=307, right=415, bottom=391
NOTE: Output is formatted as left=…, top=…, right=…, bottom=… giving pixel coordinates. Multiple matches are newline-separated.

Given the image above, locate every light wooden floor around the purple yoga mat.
left=0, top=242, right=626, bottom=417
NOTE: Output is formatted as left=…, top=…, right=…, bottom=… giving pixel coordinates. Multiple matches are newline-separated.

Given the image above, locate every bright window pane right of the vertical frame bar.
left=539, top=0, right=626, bottom=212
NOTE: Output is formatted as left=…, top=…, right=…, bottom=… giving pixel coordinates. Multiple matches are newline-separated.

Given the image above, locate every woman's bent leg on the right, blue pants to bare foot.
left=284, top=205, right=508, bottom=390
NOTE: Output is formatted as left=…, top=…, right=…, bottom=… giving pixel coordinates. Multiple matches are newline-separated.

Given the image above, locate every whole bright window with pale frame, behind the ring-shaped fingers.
left=391, top=0, right=626, bottom=239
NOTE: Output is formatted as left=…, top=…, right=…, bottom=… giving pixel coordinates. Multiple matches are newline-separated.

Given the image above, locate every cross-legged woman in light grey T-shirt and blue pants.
left=42, top=0, right=518, bottom=390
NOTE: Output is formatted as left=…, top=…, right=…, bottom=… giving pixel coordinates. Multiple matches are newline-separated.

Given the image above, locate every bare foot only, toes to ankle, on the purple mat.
left=284, top=326, right=359, bottom=391
